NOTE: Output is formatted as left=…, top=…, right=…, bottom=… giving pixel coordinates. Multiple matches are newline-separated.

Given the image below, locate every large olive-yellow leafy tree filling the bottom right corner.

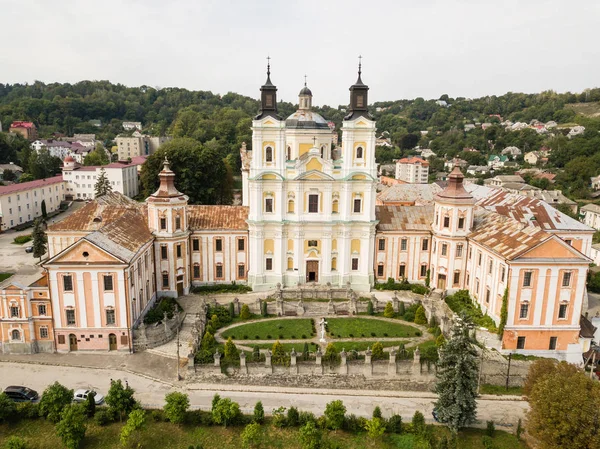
left=526, top=362, right=600, bottom=449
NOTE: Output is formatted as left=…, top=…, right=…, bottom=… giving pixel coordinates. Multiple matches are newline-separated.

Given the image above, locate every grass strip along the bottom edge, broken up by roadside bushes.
left=0, top=417, right=527, bottom=449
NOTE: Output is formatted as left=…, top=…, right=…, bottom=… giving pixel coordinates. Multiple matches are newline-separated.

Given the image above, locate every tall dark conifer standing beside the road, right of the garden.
left=435, top=314, right=478, bottom=432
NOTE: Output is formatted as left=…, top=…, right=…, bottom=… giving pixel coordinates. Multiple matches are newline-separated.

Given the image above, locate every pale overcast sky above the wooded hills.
left=0, top=0, right=600, bottom=106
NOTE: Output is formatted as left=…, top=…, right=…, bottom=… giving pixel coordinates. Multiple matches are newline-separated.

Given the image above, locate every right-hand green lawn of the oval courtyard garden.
left=327, top=318, right=421, bottom=338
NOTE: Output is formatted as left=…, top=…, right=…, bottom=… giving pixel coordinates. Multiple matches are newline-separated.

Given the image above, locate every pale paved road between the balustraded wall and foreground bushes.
left=0, top=362, right=528, bottom=425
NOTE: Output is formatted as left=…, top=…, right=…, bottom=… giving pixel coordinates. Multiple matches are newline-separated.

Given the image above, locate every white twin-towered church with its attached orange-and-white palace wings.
left=5, top=66, right=594, bottom=359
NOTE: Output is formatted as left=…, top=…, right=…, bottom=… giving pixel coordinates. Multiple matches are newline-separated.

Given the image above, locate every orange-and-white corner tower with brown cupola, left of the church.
left=146, top=157, right=190, bottom=298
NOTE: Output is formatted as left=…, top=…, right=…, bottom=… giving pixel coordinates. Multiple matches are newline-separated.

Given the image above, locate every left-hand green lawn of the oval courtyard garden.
left=222, top=318, right=313, bottom=340
